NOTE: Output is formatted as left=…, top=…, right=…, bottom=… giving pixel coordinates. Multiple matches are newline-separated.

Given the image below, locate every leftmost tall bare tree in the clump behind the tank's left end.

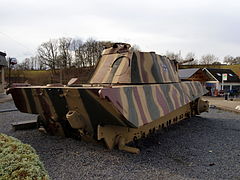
left=37, top=40, right=58, bottom=72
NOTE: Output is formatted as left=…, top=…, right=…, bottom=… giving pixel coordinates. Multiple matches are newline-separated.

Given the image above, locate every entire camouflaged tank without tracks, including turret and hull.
left=8, top=43, right=208, bottom=153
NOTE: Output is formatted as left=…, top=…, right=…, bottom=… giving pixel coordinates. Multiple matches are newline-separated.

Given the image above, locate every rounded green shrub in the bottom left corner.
left=0, top=133, right=49, bottom=180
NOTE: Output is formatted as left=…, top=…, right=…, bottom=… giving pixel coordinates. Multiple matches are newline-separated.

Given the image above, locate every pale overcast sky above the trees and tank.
left=0, top=0, right=240, bottom=61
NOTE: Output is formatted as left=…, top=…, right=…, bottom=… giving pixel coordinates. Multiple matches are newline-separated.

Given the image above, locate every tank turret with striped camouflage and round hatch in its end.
left=90, top=46, right=180, bottom=84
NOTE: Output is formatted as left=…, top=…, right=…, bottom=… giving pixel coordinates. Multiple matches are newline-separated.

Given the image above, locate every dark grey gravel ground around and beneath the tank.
left=0, top=102, right=240, bottom=180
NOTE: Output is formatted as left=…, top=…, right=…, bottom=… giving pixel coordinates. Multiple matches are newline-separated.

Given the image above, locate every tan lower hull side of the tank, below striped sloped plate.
left=98, top=103, right=195, bottom=153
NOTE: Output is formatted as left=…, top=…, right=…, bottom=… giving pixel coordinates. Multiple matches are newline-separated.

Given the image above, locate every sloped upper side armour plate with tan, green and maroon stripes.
left=100, top=82, right=207, bottom=127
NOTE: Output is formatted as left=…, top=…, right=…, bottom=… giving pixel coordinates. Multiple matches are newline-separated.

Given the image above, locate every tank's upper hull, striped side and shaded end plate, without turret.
left=8, top=82, right=207, bottom=146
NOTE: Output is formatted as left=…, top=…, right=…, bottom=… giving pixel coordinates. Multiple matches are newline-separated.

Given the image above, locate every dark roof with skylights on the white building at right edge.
left=203, top=68, right=240, bottom=83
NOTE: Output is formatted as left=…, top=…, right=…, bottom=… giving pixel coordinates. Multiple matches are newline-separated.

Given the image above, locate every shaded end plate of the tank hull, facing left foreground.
left=10, top=87, right=133, bottom=135
